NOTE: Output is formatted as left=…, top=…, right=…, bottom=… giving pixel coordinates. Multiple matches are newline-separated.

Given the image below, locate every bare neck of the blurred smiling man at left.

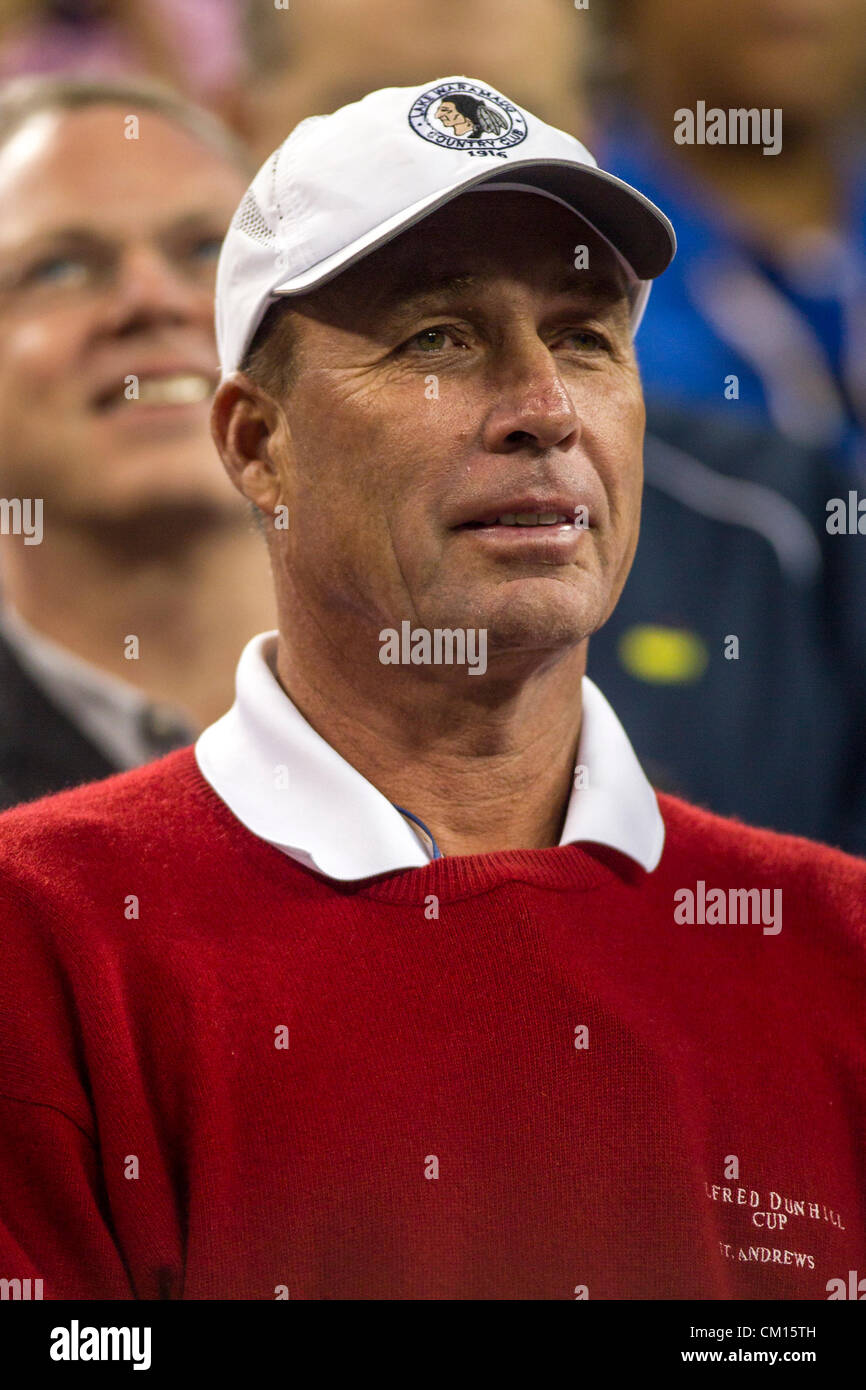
left=3, top=513, right=274, bottom=727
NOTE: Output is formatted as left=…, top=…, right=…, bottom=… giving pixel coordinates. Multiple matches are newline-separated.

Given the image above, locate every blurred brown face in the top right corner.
left=624, top=0, right=866, bottom=122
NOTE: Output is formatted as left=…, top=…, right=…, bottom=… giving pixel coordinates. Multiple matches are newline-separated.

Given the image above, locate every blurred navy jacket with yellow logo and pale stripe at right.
left=587, top=405, right=866, bottom=855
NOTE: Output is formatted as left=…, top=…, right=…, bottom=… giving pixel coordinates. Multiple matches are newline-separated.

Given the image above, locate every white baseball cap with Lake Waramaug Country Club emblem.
left=217, top=76, right=677, bottom=377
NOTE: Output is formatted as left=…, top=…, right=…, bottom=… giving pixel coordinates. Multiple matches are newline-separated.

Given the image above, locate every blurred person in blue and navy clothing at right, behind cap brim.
left=589, top=0, right=866, bottom=855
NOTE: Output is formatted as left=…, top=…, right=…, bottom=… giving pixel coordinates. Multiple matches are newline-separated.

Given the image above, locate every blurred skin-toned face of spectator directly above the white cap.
left=245, top=0, right=585, bottom=160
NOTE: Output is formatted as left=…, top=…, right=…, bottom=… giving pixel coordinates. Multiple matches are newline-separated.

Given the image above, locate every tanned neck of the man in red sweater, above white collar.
left=277, top=620, right=587, bottom=855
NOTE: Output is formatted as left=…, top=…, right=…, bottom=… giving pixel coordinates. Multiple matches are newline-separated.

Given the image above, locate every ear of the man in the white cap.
left=210, top=371, right=291, bottom=516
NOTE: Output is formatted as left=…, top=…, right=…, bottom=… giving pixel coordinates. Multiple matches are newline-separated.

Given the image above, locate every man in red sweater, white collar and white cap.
left=0, top=78, right=866, bottom=1300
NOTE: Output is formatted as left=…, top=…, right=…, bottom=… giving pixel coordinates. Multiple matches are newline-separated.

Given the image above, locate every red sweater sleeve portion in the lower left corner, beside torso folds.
left=0, top=1095, right=135, bottom=1298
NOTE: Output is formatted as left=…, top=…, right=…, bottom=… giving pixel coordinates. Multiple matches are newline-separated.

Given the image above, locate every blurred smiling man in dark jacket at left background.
left=0, top=78, right=272, bottom=805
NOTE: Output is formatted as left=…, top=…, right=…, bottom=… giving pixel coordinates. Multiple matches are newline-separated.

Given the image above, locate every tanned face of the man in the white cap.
left=261, top=192, right=644, bottom=669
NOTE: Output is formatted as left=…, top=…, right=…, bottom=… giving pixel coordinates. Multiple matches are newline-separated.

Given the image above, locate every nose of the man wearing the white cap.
left=484, top=332, right=580, bottom=453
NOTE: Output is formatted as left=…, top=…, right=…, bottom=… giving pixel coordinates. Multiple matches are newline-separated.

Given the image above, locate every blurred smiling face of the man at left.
left=0, top=106, right=245, bottom=518
